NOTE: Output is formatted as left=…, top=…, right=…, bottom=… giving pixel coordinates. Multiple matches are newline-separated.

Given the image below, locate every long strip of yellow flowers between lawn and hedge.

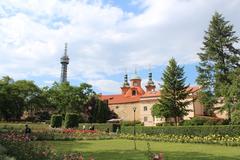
left=119, top=134, right=240, bottom=146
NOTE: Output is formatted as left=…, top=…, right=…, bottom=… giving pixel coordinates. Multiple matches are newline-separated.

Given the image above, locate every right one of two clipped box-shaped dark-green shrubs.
left=64, top=113, right=79, bottom=128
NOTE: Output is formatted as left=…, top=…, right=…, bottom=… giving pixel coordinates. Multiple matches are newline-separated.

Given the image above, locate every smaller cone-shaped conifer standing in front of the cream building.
left=153, top=58, right=191, bottom=124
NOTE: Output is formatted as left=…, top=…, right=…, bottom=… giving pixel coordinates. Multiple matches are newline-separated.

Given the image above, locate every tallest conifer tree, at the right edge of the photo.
left=196, top=12, right=240, bottom=119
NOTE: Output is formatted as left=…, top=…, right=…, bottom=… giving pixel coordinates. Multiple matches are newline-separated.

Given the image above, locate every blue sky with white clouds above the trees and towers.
left=0, top=0, right=240, bottom=94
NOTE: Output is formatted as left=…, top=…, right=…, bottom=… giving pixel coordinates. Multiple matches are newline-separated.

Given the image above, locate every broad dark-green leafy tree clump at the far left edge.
left=0, top=77, right=48, bottom=120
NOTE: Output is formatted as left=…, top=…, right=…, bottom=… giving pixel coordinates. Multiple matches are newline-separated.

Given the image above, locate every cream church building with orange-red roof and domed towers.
left=100, top=72, right=203, bottom=126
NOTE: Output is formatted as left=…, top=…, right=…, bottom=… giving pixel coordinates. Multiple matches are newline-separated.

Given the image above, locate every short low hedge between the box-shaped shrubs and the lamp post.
left=78, top=123, right=120, bottom=132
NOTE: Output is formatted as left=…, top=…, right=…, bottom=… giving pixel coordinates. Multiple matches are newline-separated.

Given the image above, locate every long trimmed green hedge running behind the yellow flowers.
left=121, top=125, right=240, bottom=136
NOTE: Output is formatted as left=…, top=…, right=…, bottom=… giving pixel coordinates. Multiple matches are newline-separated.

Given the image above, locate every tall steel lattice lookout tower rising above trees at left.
left=60, top=43, right=69, bottom=83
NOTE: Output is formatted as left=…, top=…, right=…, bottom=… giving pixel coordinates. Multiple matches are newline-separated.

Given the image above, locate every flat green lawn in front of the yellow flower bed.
left=49, top=139, right=240, bottom=160
